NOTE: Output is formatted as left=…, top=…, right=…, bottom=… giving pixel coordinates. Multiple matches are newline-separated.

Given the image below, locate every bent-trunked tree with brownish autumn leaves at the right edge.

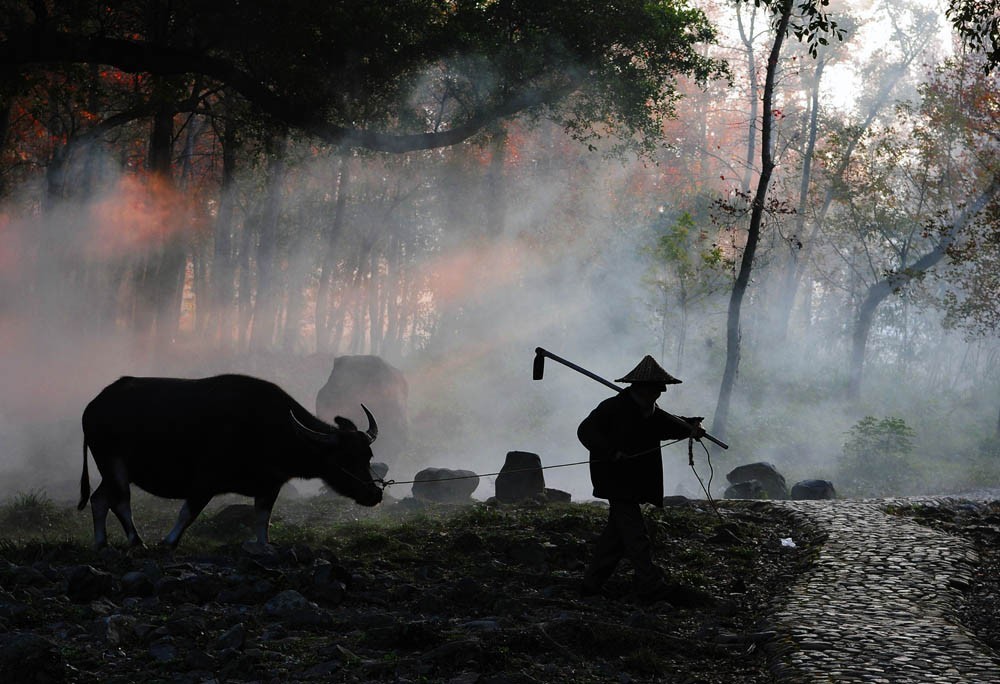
left=847, top=58, right=1000, bottom=399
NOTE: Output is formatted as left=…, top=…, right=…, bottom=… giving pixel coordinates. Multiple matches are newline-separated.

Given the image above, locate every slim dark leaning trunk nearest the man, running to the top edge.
left=712, top=0, right=792, bottom=439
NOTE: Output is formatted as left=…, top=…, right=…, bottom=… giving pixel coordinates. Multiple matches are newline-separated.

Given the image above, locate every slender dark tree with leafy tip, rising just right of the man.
left=712, top=0, right=841, bottom=436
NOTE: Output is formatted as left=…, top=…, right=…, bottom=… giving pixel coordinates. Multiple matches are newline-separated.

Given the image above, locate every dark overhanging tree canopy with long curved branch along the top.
left=0, top=0, right=721, bottom=152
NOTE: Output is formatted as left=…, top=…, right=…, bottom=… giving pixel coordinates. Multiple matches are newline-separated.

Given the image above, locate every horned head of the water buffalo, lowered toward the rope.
left=292, top=404, right=382, bottom=506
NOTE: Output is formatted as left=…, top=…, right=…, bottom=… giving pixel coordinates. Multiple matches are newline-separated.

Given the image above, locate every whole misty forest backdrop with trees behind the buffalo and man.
left=0, top=0, right=1000, bottom=498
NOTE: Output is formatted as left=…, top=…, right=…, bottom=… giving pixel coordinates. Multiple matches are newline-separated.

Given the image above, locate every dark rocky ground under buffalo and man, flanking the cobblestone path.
left=0, top=494, right=1000, bottom=684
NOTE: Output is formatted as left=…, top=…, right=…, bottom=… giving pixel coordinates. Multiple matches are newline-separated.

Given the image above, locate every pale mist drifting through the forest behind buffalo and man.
left=0, top=0, right=1000, bottom=508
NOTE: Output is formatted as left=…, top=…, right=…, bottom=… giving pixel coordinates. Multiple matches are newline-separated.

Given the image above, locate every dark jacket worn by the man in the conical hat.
left=576, top=388, right=690, bottom=506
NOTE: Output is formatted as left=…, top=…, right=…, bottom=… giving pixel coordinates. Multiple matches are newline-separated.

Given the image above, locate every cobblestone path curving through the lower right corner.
left=769, top=500, right=1000, bottom=684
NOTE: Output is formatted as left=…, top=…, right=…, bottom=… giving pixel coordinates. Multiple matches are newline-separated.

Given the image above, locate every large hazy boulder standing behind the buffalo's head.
left=316, top=355, right=409, bottom=467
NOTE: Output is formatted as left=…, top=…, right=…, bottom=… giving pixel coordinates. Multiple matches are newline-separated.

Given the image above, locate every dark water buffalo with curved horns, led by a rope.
left=78, top=375, right=382, bottom=548
